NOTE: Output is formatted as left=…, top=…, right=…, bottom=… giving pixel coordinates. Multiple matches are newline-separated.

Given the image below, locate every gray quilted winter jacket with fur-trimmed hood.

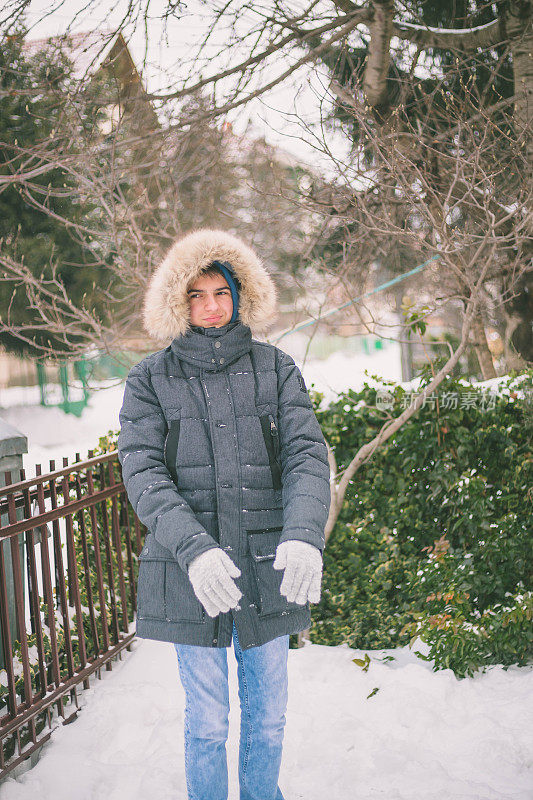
left=118, top=231, right=330, bottom=648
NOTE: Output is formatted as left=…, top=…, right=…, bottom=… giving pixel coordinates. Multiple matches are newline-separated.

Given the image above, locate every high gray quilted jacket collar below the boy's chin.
left=170, top=321, right=252, bottom=372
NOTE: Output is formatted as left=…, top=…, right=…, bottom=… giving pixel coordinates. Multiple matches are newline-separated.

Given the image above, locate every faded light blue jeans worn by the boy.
left=174, top=623, right=289, bottom=800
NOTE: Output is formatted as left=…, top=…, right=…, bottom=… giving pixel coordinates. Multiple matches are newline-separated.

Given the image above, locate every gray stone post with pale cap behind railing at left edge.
left=0, top=418, right=28, bottom=669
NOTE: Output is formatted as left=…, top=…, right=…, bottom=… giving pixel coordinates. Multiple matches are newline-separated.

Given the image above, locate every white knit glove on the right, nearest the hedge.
left=273, top=539, right=322, bottom=606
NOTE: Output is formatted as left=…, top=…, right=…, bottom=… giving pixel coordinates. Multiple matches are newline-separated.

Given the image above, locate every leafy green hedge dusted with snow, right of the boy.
left=311, top=365, right=533, bottom=676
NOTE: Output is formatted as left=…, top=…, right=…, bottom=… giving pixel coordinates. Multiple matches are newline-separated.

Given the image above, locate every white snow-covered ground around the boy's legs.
left=0, top=640, right=533, bottom=800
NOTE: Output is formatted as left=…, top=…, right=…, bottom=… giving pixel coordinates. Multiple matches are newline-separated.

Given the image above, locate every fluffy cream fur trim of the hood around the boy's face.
left=143, top=228, right=277, bottom=340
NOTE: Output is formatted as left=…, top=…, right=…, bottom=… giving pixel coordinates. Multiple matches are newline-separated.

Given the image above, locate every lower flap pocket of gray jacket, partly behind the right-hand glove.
left=247, top=528, right=309, bottom=617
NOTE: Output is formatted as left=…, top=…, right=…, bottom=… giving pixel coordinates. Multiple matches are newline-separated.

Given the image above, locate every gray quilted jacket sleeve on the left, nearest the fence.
left=118, top=364, right=218, bottom=572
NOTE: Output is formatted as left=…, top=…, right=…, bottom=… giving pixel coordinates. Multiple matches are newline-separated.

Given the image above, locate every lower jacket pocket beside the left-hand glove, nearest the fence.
left=137, top=553, right=205, bottom=623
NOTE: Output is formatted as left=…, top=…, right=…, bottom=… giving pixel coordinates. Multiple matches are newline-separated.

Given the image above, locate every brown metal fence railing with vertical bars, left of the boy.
left=0, top=451, right=145, bottom=779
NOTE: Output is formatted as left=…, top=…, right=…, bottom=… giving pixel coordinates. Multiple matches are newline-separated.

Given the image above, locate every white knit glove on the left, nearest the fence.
left=188, top=547, right=242, bottom=617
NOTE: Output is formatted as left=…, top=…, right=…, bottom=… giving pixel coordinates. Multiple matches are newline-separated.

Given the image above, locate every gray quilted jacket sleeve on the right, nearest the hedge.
left=277, top=350, right=331, bottom=553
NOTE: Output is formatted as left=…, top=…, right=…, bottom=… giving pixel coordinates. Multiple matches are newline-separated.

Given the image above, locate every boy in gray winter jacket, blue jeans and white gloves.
left=118, top=229, right=330, bottom=800
